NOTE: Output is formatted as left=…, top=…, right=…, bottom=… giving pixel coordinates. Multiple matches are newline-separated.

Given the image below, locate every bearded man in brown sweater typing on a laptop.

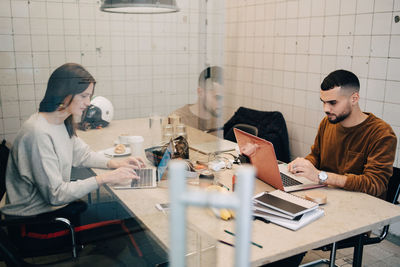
left=288, top=70, right=397, bottom=198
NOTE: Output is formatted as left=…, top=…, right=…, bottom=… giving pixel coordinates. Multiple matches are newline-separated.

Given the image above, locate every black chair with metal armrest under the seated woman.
left=0, top=140, right=77, bottom=266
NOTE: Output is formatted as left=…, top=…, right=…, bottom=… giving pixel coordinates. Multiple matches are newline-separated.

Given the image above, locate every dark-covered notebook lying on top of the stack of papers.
left=253, top=190, right=318, bottom=217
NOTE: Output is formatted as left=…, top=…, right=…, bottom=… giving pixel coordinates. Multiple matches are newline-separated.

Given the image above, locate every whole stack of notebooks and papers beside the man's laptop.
left=253, top=190, right=324, bottom=231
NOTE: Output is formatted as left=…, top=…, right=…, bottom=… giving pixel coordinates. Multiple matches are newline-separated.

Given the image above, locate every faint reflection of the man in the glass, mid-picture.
left=173, top=66, right=223, bottom=131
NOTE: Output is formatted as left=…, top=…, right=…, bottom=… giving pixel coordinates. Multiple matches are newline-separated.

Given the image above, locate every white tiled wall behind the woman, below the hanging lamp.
left=0, top=0, right=224, bottom=142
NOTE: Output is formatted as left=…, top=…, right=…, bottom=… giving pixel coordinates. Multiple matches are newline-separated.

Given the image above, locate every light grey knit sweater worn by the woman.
left=1, top=113, right=108, bottom=216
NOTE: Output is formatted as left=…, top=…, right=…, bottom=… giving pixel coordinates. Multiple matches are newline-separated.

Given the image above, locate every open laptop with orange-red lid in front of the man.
left=233, top=128, right=325, bottom=192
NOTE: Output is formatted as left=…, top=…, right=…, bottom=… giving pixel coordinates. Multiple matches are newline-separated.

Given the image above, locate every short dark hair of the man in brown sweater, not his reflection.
left=321, top=70, right=360, bottom=92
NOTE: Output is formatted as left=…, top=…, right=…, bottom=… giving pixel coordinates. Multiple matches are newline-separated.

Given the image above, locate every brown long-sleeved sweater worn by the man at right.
left=306, top=113, right=397, bottom=198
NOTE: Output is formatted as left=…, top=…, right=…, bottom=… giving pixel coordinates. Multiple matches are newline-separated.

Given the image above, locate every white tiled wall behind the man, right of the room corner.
left=224, top=0, right=400, bottom=167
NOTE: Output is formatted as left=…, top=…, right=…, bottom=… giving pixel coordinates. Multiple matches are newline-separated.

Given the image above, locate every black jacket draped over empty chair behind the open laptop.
left=224, top=107, right=290, bottom=162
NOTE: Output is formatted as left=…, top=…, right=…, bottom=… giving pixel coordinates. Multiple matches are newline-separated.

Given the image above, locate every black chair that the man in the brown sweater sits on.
left=301, top=167, right=400, bottom=267
